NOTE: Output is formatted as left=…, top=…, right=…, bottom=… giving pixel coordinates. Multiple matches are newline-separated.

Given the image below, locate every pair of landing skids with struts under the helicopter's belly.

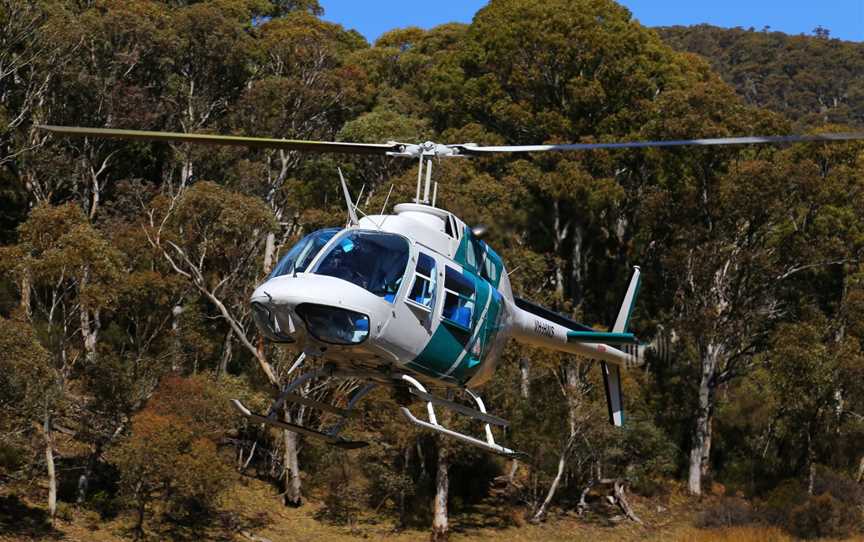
left=231, top=368, right=525, bottom=458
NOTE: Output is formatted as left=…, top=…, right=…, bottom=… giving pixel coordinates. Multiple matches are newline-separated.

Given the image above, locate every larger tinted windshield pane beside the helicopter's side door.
left=313, top=230, right=408, bottom=303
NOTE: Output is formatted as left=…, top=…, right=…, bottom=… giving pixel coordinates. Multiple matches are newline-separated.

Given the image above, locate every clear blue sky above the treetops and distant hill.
left=319, top=0, right=864, bottom=42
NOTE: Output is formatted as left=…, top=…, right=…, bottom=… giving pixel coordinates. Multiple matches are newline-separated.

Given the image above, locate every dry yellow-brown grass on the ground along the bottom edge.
left=0, top=479, right=860, bottom=542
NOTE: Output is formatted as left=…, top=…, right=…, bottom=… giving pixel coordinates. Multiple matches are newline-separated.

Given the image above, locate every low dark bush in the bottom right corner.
left=789, top=493, right=861, bottom=538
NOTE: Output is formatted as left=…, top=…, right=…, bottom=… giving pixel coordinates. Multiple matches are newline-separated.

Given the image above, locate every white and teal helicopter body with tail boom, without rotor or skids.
left=251, top=203, right=633, bottom=388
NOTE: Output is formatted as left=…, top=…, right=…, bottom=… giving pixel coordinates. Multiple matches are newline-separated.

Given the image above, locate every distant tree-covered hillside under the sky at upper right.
left=656, top=24, right=864, bottom=127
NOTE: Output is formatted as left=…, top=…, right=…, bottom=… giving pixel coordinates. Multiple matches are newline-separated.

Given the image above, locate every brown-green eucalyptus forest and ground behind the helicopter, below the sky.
left=0, top=0, right=864, bottom=542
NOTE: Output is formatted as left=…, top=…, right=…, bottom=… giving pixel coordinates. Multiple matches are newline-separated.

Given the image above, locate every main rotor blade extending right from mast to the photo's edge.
left=451, top=133, right=864, bottom=156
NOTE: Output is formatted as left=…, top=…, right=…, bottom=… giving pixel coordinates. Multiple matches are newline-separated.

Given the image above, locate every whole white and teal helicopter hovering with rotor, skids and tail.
left=39, top=126, right=864, bottom=458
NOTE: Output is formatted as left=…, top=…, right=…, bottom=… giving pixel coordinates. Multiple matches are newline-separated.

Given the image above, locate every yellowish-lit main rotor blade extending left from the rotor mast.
left=38, top=125, right=405, bottom=154
